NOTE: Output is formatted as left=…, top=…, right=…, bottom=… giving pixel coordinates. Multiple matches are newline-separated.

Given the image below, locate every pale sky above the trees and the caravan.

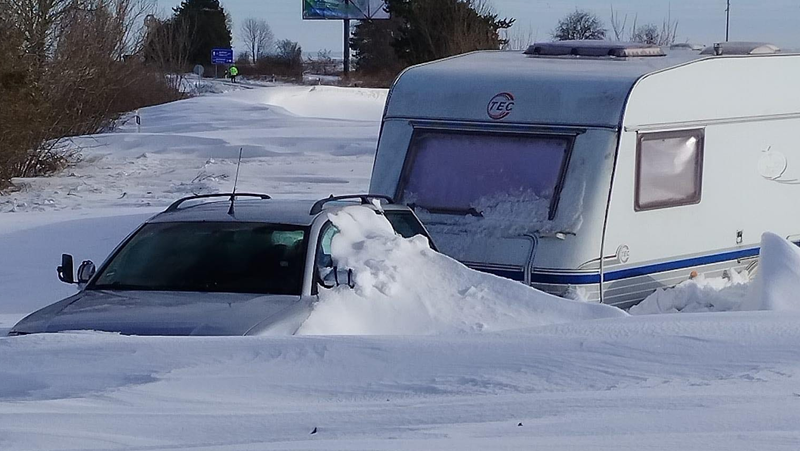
left=159, top=0, right=800, bottom=54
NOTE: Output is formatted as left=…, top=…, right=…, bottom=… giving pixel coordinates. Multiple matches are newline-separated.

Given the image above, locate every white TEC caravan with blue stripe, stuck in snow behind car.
left=370, top=41, right=800, bottom=307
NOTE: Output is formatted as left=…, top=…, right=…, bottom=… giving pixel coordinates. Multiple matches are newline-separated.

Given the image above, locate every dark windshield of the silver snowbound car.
left=88, top=222, right=307, bottom=295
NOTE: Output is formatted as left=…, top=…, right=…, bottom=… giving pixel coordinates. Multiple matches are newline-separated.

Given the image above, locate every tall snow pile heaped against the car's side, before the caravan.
left=298, top=207, right=627, bottom=335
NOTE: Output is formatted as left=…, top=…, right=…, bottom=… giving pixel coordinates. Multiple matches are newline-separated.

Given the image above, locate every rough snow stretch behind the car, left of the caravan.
left=0, top=84, right=386, bottom=212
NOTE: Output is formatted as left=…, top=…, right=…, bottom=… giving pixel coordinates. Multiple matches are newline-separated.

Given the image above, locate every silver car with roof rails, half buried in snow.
left=9, top=193, right=435, bottom=335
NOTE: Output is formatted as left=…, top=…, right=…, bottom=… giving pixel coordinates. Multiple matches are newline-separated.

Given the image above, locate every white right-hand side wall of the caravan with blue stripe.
left=604, top=56, right=800, bottom=304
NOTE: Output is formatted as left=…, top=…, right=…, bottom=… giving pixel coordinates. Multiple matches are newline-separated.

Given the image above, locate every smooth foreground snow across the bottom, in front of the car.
left=0, top=312, right=800, bottom=451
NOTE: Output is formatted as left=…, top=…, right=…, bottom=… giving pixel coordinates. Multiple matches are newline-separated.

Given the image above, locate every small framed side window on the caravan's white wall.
left=635, top=130, right=703, bottom=211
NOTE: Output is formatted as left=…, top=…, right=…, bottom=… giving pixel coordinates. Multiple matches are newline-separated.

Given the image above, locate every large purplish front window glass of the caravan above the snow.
left=399, top=131, right=572, bottom=219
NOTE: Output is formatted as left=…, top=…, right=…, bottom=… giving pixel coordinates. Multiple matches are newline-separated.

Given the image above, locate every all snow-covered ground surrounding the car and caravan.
left=0, top=86, right=800, bottom=451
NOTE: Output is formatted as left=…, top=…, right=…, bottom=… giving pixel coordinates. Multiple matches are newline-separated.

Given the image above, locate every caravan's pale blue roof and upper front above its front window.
left=386, top=51, right=701, bottom=128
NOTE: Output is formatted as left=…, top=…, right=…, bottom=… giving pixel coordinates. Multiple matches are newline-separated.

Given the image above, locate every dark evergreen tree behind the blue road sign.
left=173, top=0, right=231, bottom=64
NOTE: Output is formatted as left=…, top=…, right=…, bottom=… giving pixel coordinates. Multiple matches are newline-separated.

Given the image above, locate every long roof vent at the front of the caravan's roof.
left=525, top=41, right=666, bottom=58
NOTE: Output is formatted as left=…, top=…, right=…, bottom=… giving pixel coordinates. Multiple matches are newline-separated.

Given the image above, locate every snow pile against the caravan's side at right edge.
left=630, top=233, right=800, bottom=315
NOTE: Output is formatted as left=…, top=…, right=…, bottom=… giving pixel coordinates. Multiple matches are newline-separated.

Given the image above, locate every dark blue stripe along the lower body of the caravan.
left=531, top=247, right=760, bottom=285
